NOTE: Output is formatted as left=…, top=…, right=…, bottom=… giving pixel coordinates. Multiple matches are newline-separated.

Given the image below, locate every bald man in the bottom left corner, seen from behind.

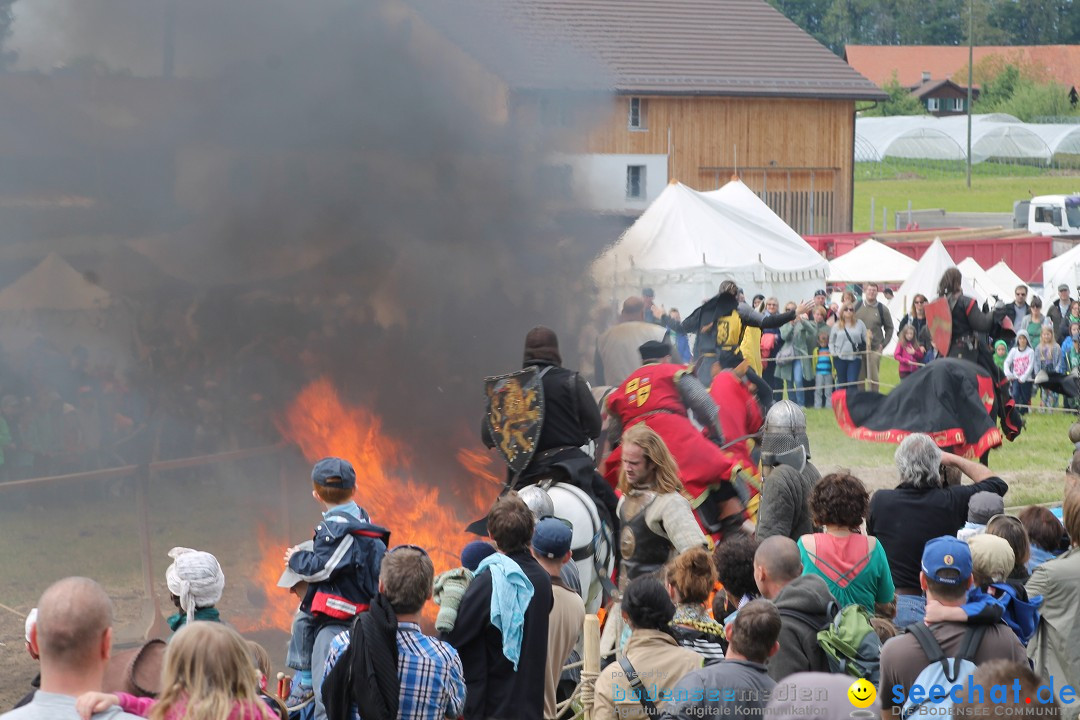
left=0, top=578, right=136, bottom=720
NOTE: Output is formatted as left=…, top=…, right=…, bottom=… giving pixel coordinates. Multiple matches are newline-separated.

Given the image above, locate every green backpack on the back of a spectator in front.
left=780, top=602, right=881, bottom=685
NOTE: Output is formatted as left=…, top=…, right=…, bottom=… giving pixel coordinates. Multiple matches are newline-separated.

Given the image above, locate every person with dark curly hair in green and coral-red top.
left=798, top=473, right=895, bottom=615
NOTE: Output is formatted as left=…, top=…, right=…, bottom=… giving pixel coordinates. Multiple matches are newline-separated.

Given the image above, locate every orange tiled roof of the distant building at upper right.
left=845, top=45, right=1080, bottom=87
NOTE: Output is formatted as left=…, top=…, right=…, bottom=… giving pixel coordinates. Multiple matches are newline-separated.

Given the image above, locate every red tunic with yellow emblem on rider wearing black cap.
left=604, top=363, right=735, bottom=499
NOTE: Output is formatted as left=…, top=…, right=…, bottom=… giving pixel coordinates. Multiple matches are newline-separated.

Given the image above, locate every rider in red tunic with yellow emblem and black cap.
left=605, top=341, right=754, bottom=535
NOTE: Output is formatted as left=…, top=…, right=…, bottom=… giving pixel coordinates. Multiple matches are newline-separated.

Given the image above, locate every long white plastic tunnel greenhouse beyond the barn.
left=855, top=113, right=1058, bottom=165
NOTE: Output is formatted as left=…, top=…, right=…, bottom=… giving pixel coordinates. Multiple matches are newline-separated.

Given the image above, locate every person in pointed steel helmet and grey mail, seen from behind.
left=757, top=400, right=821, bottom=540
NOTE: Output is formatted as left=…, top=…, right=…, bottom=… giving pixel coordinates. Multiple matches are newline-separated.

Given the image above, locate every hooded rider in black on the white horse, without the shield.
left=481, top=325, right=618, bottom=528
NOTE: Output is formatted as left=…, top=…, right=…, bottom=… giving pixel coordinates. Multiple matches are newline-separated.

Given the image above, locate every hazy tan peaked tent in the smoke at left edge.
left=0, top=253, right=112, bottom=312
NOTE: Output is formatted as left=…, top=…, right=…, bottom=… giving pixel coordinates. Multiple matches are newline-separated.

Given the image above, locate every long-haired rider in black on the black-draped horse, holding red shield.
left=937, top=268, right=1023, bottom=440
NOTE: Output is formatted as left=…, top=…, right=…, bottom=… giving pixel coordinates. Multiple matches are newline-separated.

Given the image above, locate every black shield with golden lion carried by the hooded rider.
left=484, top=367, right=543, bottom=474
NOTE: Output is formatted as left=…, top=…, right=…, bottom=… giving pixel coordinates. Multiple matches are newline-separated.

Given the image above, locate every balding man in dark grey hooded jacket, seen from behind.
left=754, top=535, right=836, bottom=681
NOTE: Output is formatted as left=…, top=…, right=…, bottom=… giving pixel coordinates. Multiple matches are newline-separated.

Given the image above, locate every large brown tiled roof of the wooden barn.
left=413, top=0, right=883, bottom=99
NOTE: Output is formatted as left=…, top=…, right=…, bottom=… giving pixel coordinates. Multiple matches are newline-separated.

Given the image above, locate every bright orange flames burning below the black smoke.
left=247, top=378, right=501, bottom=629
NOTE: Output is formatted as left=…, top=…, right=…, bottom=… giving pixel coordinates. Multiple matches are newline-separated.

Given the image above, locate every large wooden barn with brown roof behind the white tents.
left=409, top=0, right=886, bottom=233
